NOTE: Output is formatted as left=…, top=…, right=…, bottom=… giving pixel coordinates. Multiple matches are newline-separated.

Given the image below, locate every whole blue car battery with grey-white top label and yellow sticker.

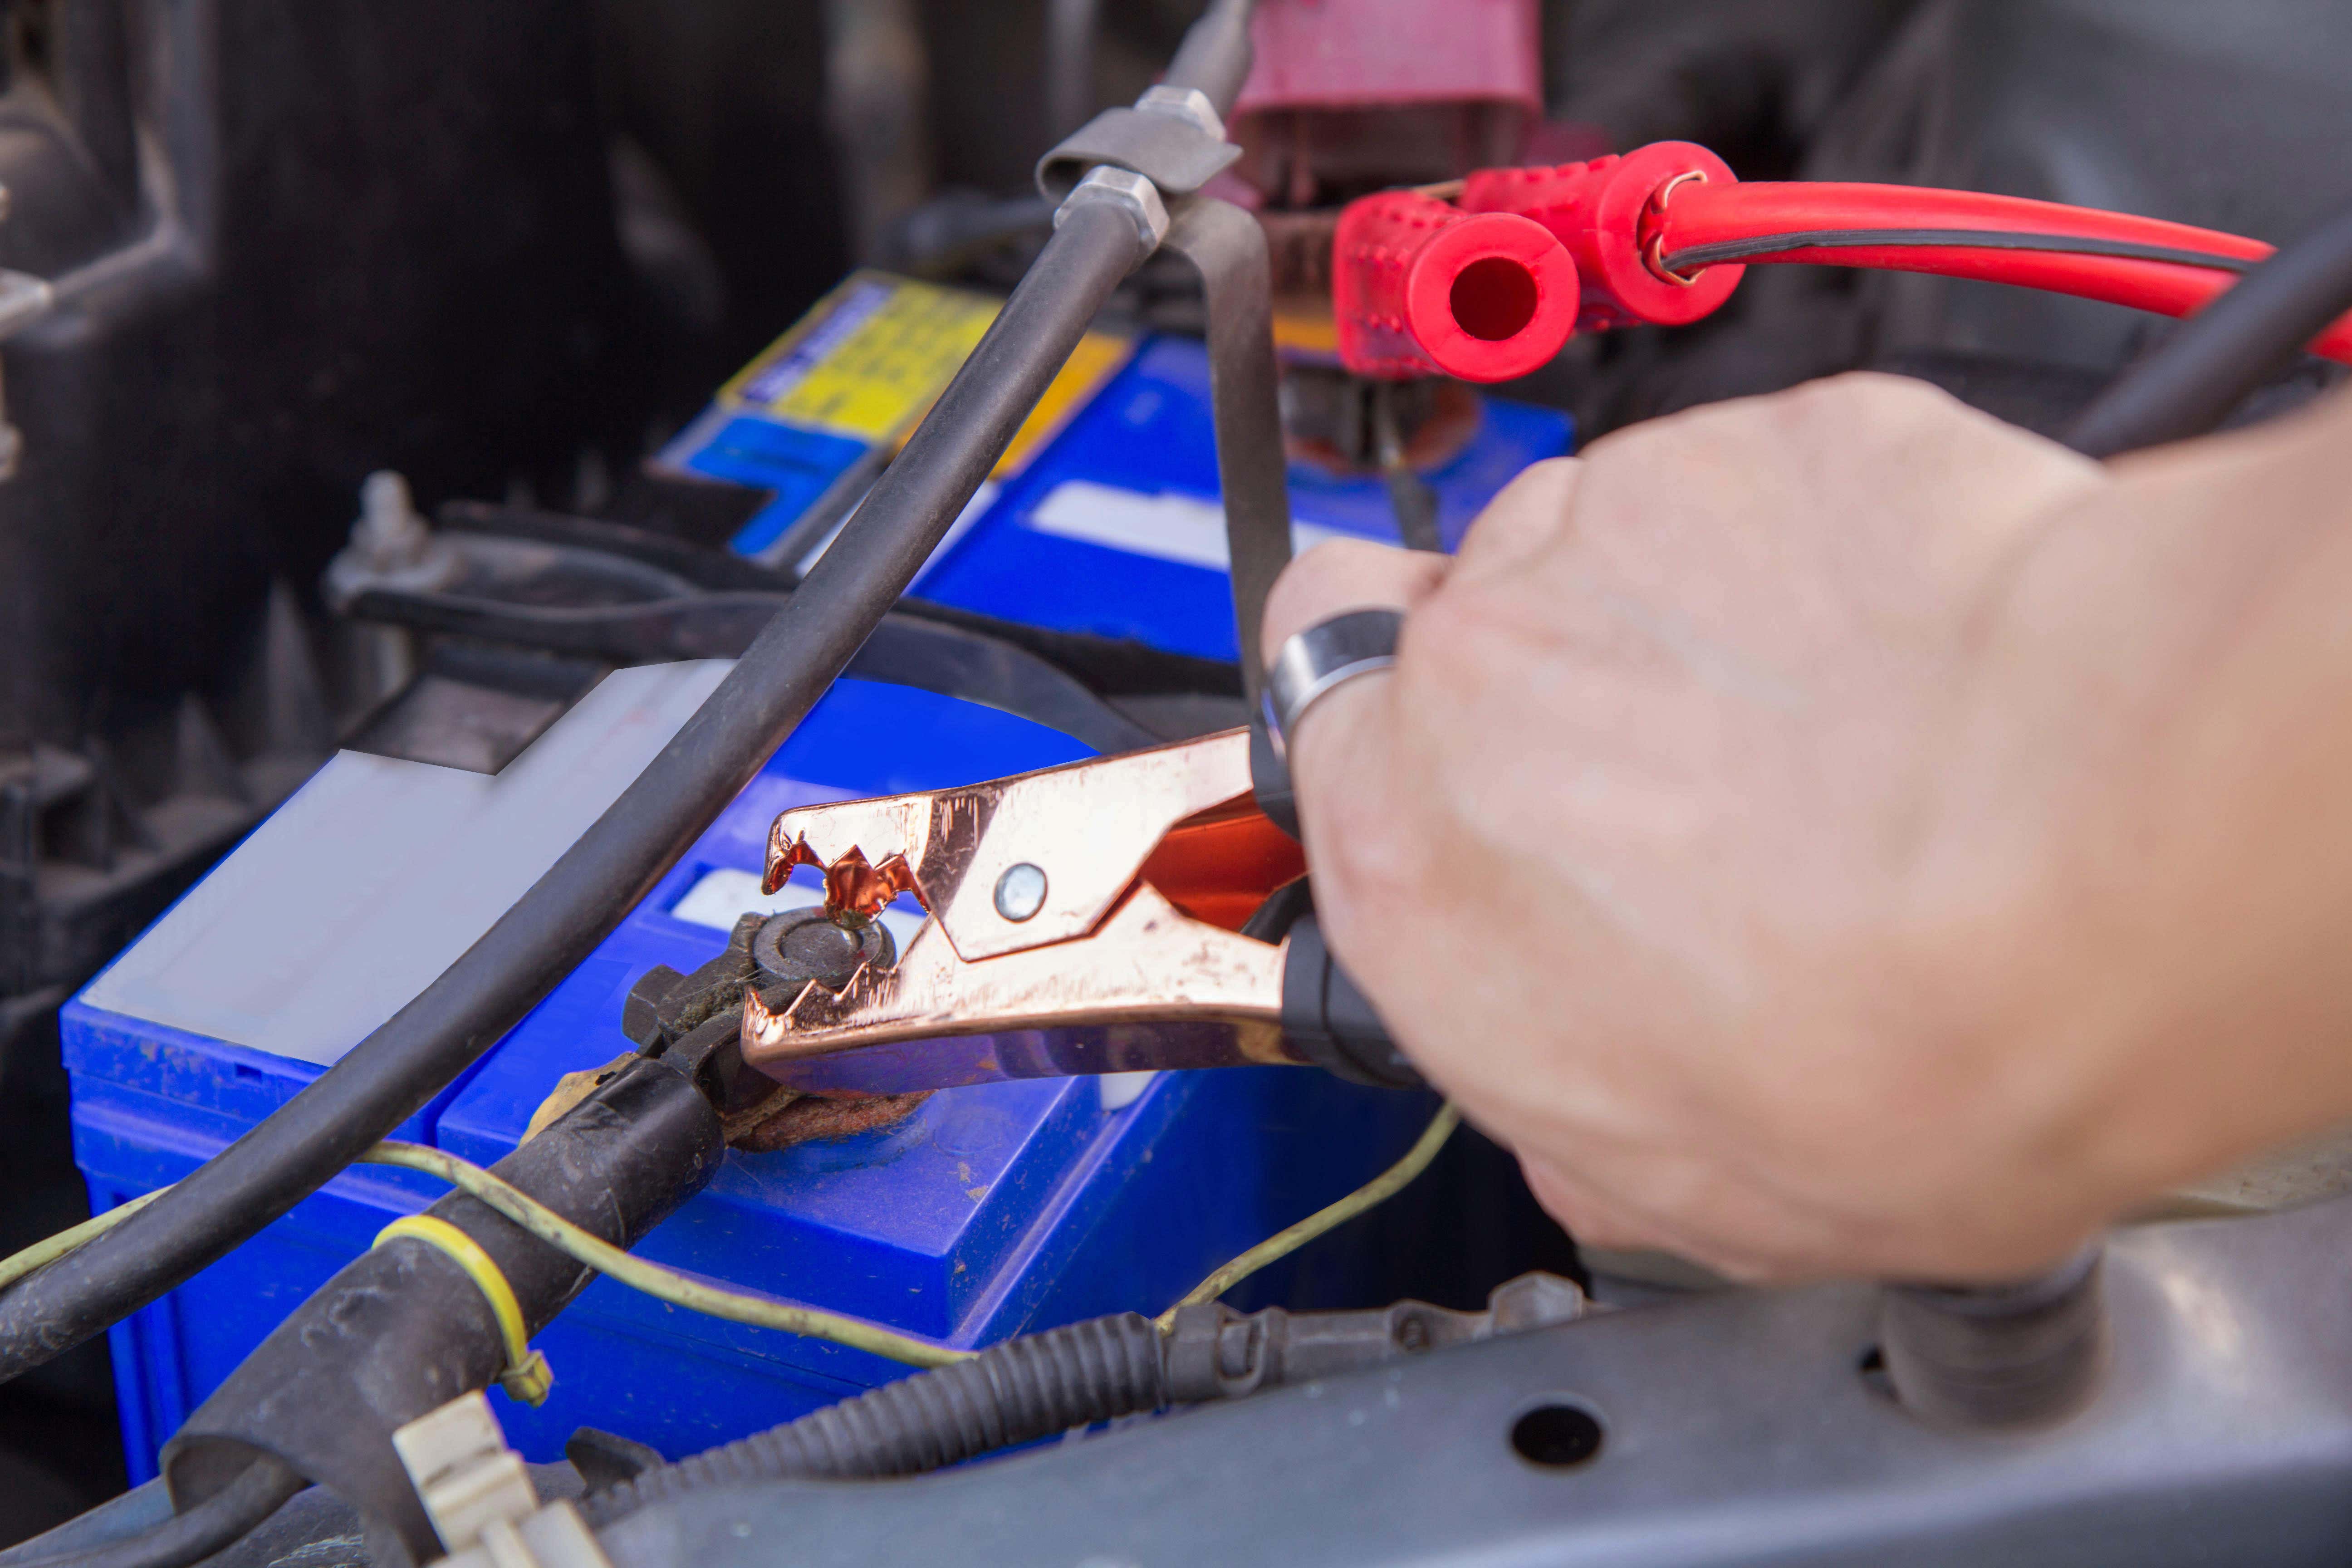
left=61, top=275, right=1567, bottom=1479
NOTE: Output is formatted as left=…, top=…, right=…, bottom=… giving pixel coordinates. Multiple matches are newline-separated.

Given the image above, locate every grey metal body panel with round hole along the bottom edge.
left=604, top=1201, right=2352, bottom=1568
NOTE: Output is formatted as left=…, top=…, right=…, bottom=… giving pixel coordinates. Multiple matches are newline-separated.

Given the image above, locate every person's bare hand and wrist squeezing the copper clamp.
left=1265, top=376, right=2352, bottom=1279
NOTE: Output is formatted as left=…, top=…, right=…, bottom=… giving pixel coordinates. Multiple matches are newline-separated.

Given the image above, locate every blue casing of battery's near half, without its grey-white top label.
left=64, top=682, right=1428, bottom=1476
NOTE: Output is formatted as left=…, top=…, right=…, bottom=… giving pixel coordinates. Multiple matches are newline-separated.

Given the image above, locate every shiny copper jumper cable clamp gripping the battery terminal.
left=743, top=729, right=1418, bottom=1093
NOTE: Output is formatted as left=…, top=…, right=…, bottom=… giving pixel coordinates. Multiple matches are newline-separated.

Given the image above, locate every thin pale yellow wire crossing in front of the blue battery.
left=0, top=1105, right=1460, bottom=1366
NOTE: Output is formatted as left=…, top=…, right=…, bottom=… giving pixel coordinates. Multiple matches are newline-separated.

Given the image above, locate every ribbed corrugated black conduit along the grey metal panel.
left=581, top=1312, right=1169, bottom=1526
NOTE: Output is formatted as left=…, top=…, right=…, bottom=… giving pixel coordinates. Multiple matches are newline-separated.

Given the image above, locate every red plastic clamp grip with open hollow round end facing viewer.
left=1331, top=191, right=1578, bottom=381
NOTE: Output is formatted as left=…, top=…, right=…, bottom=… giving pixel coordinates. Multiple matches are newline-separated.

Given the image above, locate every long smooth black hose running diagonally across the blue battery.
left=0, top=205, right=1143, bottom=1380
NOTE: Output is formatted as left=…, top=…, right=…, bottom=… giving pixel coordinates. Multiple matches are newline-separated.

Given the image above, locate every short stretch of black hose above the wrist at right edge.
left=2065, top=211, right=2352, bottom=458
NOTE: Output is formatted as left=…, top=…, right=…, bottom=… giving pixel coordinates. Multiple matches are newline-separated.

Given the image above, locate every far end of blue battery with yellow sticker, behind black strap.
left=661, top=273, right=1571, bottom=658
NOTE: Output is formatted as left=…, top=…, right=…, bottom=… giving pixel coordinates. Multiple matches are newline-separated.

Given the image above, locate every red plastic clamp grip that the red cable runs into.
left=1460, top=141, right=1745, bottom=327
